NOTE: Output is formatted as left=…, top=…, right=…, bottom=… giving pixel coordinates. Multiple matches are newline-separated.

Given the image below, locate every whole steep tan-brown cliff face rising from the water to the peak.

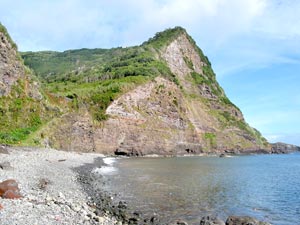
left=34, top=29, right=270, bottom=155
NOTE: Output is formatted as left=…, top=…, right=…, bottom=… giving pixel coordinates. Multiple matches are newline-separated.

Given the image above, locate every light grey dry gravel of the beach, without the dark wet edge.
left=0, top=148, right=120, bottom=225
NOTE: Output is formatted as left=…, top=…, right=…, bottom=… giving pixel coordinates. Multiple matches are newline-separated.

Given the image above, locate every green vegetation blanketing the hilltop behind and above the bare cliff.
left=21, top=27, right=195, bottom=125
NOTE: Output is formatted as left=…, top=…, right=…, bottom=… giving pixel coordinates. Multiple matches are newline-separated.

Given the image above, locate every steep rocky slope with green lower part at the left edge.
left=0, top=23, right=61, bottom=144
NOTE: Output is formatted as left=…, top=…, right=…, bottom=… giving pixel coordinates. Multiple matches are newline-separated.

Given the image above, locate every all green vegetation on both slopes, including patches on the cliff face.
left=0, top=24, right=263, bottom=148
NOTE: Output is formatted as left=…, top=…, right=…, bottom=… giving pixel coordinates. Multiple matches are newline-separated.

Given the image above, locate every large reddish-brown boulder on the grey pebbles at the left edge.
left=0, top=179, right=22, bottom=199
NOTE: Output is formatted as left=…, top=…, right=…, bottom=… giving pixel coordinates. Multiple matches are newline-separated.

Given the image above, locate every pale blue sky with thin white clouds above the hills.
left=0, top=0, right=300, bottom=145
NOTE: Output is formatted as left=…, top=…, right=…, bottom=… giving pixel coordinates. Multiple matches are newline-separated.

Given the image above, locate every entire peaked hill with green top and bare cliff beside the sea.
left=22, top=27, right=270, bottom=155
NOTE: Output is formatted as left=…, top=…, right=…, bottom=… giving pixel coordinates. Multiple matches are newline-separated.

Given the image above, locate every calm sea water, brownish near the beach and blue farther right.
left=101, top=153, right=300, bottom=225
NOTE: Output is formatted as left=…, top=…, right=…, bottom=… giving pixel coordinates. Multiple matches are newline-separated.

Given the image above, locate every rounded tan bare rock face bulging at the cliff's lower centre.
left=94, top=77, right=202, bottom=155
